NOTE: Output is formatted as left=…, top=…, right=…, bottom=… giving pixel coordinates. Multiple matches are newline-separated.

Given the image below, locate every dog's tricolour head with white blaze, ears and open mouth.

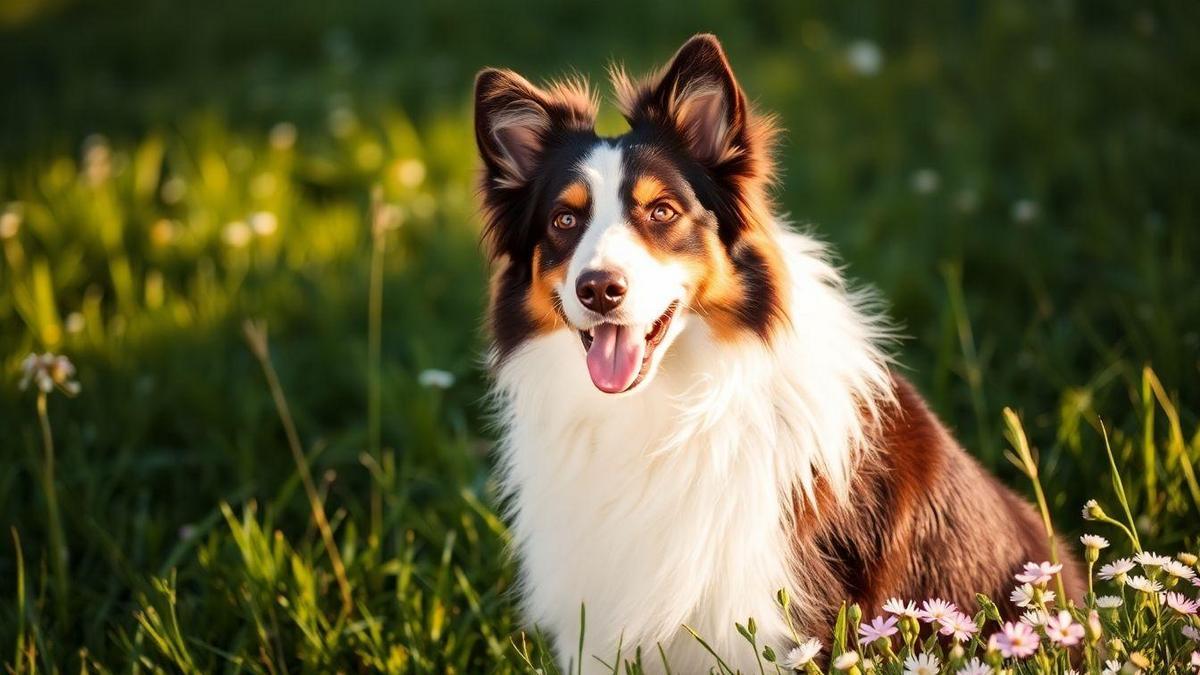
left=475, top=35, right=786, bottom=394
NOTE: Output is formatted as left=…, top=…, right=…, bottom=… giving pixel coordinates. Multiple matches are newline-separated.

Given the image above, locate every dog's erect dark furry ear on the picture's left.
left=475, top=68, right=595, bottom=187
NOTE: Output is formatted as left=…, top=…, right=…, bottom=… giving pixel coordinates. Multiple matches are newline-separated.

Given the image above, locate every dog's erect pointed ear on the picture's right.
left=613, top=34, right=746, bottom=165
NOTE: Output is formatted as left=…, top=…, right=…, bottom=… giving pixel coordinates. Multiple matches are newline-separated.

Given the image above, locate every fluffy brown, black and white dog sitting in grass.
left=474, top=35, right=1082, bottom=673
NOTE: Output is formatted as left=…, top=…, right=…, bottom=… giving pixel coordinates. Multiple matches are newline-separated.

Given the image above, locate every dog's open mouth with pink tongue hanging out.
left=580, top=300, right=679, bottom=394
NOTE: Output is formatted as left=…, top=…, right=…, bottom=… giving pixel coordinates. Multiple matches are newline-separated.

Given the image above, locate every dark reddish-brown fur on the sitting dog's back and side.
left=793, top=376, right=1084, bottom=637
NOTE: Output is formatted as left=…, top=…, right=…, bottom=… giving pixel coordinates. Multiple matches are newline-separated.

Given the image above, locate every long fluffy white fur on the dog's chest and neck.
left=496, top=228, right=887, bottom=673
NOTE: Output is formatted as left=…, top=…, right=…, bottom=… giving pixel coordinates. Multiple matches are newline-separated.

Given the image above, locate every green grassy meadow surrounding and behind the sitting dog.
left=0, top=0, right=1200, bottom=673
